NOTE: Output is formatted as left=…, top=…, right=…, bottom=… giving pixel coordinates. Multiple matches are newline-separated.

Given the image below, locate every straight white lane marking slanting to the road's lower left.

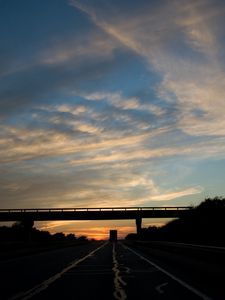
left=9, top=242, right=108, bottom=300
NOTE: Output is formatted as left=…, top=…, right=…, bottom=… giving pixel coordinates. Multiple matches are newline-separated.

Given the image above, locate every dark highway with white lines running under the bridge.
left=0, top=242, right=225, bottom=300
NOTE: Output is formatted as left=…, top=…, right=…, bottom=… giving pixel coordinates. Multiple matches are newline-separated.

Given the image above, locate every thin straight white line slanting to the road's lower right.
left=122, top=245, right=212, bottom=300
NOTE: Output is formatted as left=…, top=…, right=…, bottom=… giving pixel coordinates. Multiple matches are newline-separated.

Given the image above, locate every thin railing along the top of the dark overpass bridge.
left=0, top=206, right=192, bottom=213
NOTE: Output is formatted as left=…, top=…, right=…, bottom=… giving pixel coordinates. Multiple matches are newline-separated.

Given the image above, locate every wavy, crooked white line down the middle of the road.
left=112, top=243, right=127, bottom=300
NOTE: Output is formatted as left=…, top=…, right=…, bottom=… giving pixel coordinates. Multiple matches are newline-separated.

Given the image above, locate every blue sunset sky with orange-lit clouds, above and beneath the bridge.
left=0, top=0, right=225, bottom=238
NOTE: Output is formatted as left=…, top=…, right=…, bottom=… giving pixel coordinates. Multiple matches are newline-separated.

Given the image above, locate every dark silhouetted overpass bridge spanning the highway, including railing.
left=0, top=206, right=192, bottom=233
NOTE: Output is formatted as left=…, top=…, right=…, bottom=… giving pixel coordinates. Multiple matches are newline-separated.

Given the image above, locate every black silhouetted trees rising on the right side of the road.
left=126, top=197, right=225, bottom=245
